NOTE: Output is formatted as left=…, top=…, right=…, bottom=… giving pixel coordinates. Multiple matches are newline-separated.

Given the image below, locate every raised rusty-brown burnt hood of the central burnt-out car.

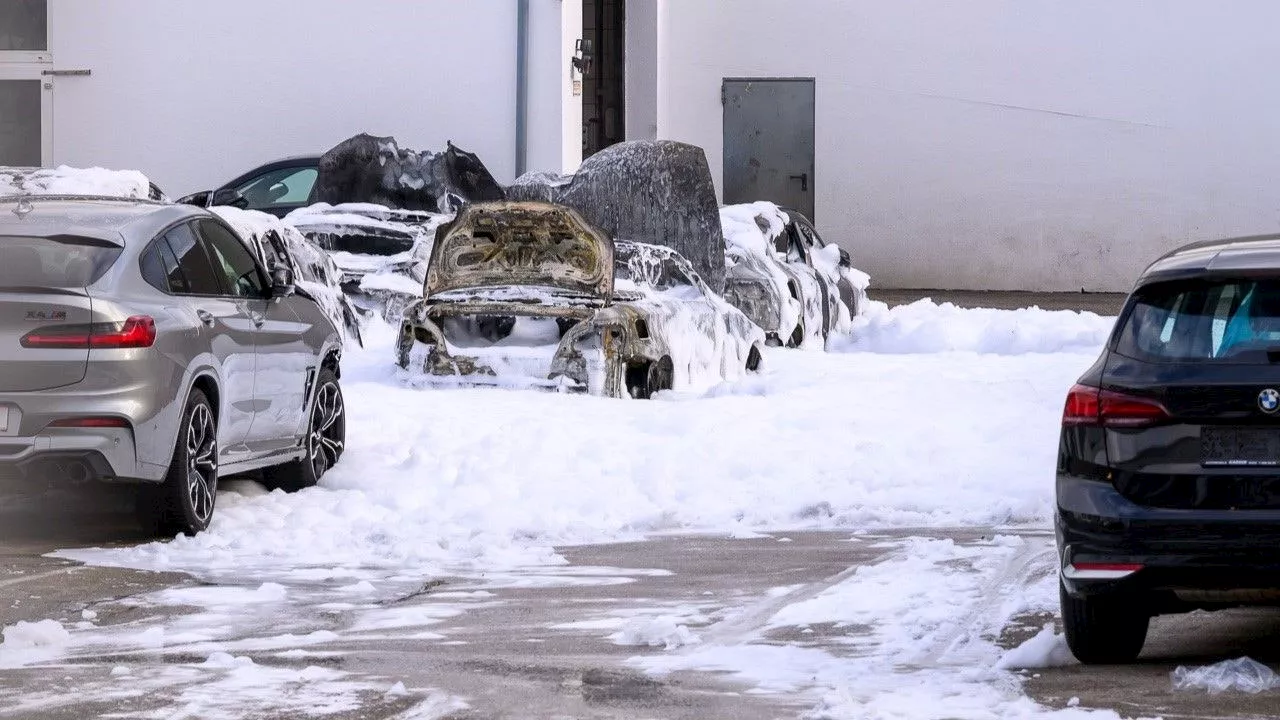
left=426, top=202, right=613, bottom=299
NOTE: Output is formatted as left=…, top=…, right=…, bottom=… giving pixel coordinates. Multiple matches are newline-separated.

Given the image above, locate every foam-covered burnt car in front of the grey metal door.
left=721, top=202, right=868, bottom=347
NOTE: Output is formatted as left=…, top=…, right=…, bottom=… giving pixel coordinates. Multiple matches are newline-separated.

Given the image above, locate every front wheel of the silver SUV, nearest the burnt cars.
left=262, top=368, right=347, bottom=492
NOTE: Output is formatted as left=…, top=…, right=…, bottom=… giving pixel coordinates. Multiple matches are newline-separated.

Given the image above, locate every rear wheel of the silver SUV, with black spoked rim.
left=134, top=389, right=218, bottom=537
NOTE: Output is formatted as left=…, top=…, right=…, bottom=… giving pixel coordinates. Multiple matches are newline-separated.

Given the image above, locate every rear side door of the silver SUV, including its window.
left=165, top=223, right=256, bottom=450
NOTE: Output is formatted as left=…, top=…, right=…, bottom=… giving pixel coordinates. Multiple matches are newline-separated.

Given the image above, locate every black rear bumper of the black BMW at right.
left=1055, top=474, right=1280, bottom=602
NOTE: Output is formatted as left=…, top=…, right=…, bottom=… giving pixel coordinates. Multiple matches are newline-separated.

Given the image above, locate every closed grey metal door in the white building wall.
left=721, top=78, right=815, bottom=219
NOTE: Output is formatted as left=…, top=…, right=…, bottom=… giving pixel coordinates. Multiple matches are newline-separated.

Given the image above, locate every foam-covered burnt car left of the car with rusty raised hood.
left=284, top=202, right=452, bottom=316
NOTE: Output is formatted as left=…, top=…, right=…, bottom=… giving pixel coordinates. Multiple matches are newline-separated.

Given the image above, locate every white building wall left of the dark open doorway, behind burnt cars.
left=49, top=0, right=563, bottom=196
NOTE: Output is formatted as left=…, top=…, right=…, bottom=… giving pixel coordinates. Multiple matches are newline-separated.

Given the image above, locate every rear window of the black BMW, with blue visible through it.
left=1116, top=279, right=1280, bottom=364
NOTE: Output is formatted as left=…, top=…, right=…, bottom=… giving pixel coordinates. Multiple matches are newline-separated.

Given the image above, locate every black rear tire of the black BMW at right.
left=1057, top=580, right=1151, bottom=665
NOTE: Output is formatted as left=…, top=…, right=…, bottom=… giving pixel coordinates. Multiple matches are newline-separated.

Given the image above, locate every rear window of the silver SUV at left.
left=0, top=236, right=120, bottom=290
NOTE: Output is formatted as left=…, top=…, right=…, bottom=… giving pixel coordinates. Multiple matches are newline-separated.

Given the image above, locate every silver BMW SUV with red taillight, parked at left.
left=0, top=196, right=346, bottom=536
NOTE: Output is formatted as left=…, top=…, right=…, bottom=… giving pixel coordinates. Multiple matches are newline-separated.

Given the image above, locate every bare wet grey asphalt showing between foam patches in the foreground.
left=0, top=492, right=1280, bottom=720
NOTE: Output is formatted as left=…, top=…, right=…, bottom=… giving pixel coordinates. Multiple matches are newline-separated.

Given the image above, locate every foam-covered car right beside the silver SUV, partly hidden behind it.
left=210, top=206, right=362, bottom=345
